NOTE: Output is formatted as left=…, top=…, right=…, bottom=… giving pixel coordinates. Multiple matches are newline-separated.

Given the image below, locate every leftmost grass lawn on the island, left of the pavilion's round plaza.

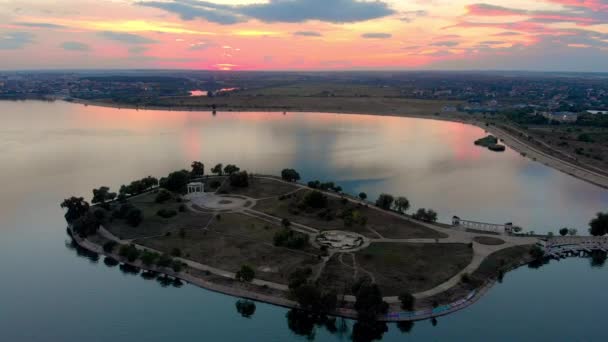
left=104, top=192, right=211, bottom=239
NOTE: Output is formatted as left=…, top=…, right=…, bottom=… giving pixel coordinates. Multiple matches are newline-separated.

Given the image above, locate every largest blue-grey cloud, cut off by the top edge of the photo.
left=137, top=0, right=395, bottom=25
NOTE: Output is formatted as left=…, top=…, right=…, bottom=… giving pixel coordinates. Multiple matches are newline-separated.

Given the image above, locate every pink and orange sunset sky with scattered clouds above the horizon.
left=0, top=0, right=608, bottom=72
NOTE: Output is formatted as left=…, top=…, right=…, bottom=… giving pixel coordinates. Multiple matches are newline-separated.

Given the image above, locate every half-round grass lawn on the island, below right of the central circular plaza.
left=356, top=243, right=473, bottom=296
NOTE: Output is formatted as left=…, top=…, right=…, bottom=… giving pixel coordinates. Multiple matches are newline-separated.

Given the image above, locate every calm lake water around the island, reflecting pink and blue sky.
left=0, top=102, right=608, bottom=341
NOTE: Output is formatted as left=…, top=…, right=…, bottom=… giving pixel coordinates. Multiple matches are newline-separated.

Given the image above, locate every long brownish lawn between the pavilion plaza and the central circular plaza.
left=136, top=229, right=319, bottom=284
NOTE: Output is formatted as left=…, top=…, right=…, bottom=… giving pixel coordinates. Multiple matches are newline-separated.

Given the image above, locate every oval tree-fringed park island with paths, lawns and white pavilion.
left=61, top=162, right=544, bottom=324
